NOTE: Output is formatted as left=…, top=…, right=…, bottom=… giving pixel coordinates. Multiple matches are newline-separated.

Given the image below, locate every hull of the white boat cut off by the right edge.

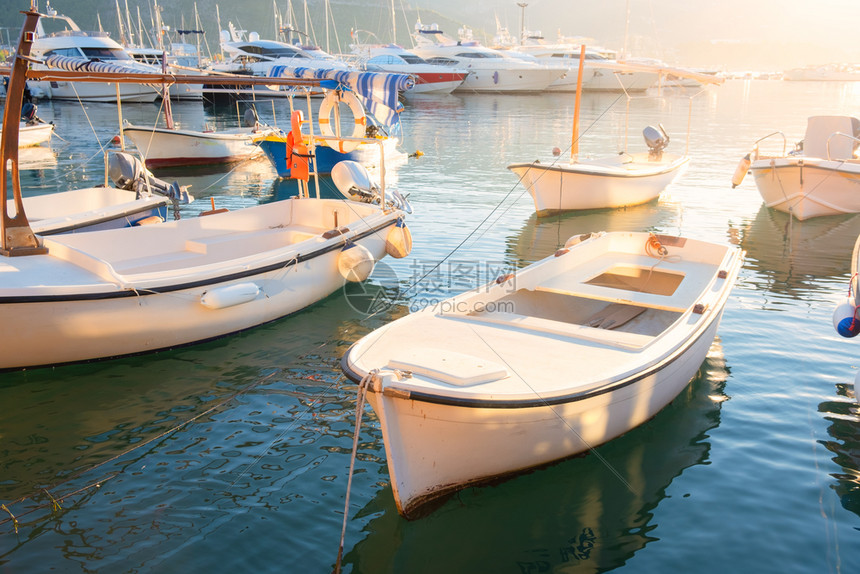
left=750, top=157, right=860, bottom=221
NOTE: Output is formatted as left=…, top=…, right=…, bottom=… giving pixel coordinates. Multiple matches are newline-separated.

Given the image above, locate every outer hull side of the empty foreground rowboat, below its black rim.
left=368, top=316, right=720, bottom=518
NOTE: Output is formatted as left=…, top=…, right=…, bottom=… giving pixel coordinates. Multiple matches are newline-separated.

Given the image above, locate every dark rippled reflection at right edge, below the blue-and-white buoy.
left=818, top=383, right=860, bottom=516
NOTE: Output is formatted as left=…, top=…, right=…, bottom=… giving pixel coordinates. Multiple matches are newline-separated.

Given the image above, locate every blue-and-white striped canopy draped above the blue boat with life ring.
left=269, top=66, right=415, bottom=128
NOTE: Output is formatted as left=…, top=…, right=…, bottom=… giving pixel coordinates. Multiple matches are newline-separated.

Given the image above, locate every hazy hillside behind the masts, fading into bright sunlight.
left=0, top=0, right=860, bottom=70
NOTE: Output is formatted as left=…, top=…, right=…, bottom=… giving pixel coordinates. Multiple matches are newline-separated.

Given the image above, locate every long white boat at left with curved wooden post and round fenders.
left=0, top=6, right=411, bottom=369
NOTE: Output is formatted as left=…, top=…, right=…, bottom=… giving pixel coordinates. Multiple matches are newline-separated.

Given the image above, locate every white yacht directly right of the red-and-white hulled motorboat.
left=412, top=22, right=565, bottom=93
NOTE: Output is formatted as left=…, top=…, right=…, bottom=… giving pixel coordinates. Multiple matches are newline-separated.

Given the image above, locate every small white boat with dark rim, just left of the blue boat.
left=122, top=123, right=274, bottom=168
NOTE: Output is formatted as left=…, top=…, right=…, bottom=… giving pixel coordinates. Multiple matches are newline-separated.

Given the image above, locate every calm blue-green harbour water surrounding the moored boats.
left=0, top=81, right=860, bottom=574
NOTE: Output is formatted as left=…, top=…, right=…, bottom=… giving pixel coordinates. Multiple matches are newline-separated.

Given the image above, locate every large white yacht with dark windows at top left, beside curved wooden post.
left=29, top=10, right=160, bottom=102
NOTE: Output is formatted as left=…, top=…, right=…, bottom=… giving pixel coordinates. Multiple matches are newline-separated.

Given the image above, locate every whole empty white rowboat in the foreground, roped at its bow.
left=342, top=232, right=743, bottom=517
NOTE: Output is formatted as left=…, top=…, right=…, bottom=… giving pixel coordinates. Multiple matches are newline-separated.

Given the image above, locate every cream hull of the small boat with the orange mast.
left=508, top=154, right=689, bottom=216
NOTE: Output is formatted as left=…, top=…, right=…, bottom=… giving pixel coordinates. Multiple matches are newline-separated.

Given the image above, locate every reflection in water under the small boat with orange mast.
left=507, top=201, right=679, bottom=264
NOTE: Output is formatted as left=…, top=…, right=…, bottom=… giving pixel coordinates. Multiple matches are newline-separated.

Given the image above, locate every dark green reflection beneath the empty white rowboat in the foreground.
left=344, top=339, right=728, bottom=574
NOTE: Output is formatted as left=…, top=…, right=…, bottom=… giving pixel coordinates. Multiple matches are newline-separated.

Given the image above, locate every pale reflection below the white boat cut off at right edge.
left=729, top=205, right=860, bottom=298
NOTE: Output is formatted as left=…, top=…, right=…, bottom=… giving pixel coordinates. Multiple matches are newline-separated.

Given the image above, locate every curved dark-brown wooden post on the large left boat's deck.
left=0, top=4, right=48, bottom=257
